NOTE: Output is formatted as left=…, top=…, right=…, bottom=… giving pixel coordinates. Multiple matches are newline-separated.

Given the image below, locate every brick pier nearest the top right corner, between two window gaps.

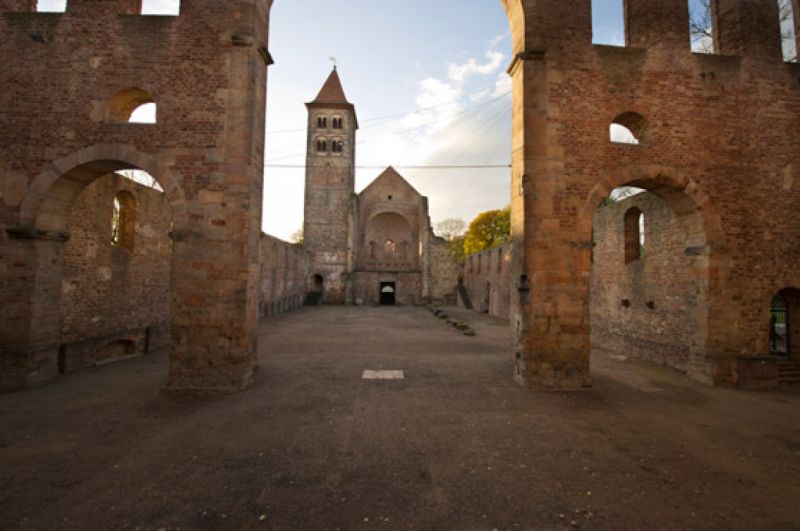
left=712, top=0, right=781, bottom=61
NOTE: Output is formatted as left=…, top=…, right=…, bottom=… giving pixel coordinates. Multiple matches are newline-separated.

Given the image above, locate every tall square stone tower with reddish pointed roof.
left=303, top=68, right=358, bottom=304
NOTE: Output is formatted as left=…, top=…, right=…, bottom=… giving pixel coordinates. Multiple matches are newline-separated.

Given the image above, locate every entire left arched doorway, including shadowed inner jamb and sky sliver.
left=3, top=154, right=183, bottom=387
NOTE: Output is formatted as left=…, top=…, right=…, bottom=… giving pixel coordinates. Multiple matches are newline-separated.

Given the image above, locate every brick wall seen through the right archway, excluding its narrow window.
left=590, top=193, right=696, bottom=371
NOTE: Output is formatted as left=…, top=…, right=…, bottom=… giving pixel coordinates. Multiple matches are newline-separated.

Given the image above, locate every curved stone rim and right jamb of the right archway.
left=579, top=165, right=735, bottom=383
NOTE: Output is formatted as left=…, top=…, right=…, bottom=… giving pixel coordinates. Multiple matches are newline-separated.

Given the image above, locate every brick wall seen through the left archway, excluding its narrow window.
left=61, top=174, right=172, bottom=371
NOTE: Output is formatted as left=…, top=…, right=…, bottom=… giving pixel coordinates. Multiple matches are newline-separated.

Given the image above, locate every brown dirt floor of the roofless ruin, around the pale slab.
left=0, top=307, right=800, bottom=531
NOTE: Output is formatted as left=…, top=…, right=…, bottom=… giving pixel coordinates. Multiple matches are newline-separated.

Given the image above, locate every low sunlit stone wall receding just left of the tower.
left=259, top=234, right=310, bottom=318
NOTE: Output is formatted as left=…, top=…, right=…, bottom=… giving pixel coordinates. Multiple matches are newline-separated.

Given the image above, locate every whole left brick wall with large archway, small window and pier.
left=0, top=0, right=271, bottom=391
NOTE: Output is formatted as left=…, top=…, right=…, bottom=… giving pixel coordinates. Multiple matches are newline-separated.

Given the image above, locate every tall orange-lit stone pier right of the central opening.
left=509, top=0, right=591, bottom=389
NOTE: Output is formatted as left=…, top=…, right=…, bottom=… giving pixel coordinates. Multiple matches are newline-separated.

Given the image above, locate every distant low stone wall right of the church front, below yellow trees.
left=462, top=244, right=512, bottom=319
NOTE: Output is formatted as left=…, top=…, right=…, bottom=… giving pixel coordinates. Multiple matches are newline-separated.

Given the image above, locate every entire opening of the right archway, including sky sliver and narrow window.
left=589, top=185, right=709, bottom=372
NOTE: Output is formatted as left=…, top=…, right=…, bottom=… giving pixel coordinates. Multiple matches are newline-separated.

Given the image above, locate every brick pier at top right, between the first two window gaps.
left=625, top=0, right=690, bottom=51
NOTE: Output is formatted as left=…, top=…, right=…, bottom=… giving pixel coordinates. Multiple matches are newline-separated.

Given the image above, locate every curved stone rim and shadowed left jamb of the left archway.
left=6, top=145, right=185, bottom=387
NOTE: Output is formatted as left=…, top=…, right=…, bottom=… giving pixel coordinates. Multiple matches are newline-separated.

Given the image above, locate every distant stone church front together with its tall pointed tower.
left=304, top=69, right=460, bottom=305
